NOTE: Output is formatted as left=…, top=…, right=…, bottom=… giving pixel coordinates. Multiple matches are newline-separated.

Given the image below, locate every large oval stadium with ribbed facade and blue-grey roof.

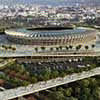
left=5, top=28, right=97, bottom=46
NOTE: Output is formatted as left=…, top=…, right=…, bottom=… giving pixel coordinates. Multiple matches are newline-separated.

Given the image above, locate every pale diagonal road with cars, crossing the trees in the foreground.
left=0, top=67, right=100, bottom=100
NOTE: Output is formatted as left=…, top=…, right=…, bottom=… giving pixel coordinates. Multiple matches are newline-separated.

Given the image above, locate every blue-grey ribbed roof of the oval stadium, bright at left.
left=6, top=28, right=93, bottom=37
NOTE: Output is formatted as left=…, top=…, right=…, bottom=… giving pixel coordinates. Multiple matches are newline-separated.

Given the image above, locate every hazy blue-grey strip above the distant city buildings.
left=0, top=0, right=100, bottom=6
